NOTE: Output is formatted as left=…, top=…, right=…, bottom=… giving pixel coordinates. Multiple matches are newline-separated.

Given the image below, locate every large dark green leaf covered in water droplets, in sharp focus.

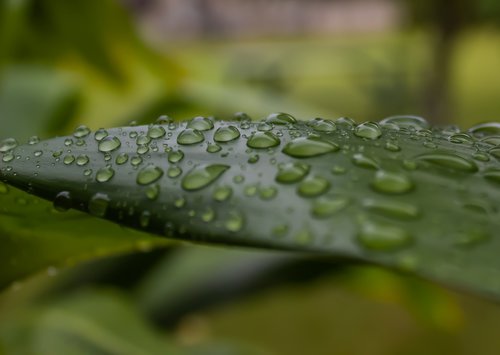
left=0, top=114, right=500, bottom=297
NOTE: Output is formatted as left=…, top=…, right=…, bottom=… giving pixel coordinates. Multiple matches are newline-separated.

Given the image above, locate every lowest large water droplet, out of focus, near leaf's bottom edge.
left=357, top=221, right=413, bottom=251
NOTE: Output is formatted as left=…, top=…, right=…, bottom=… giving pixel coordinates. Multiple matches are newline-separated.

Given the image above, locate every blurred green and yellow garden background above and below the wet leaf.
left=0, top=0, right=500, bottom=355
